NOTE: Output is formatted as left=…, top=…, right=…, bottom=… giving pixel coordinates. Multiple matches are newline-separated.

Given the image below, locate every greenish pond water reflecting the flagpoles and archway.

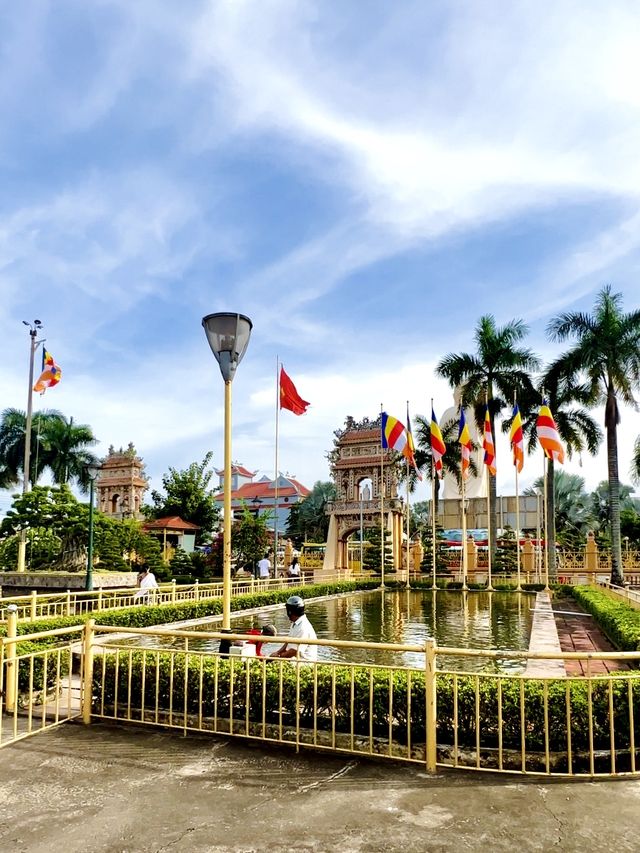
left=111, top=590, right=535, bottom=673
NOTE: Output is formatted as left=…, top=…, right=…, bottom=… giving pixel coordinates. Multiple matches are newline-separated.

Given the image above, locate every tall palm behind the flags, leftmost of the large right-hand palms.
left=436, top=314, right=540, bottom=556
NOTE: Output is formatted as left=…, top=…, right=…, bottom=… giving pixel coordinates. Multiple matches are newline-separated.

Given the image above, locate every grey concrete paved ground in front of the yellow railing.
left=0, top=724, right=640, bottom=853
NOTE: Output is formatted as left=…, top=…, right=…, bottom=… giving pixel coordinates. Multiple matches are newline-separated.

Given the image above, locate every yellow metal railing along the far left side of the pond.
left=0, top=570, right=349, bottom=622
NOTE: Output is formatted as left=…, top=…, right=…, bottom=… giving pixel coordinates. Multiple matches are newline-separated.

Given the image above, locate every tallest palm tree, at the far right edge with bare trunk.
left=547, top=286, right=640, bottom=584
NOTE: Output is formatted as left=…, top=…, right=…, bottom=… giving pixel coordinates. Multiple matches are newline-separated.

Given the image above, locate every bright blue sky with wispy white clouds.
left=0, top=0, right=640, bottom=513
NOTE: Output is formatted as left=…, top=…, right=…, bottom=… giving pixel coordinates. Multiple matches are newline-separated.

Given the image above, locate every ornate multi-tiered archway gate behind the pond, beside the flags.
left=322, top=416, right=404, bottom=571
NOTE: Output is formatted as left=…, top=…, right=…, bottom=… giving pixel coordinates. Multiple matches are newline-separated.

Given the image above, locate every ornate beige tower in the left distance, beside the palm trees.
left=96, top=442, right=149, bottom=520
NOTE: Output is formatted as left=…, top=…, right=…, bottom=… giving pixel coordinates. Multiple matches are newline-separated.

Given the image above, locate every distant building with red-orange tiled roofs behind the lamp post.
left=214, top=463, right=311, bottom=533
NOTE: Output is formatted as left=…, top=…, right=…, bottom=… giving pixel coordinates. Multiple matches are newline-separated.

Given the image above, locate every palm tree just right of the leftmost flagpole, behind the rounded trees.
left=43, top=414, right=98, bottom=492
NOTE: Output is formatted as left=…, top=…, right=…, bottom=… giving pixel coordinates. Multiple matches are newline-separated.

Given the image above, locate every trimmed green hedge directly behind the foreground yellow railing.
left=94, top=650, right=640, bottom=753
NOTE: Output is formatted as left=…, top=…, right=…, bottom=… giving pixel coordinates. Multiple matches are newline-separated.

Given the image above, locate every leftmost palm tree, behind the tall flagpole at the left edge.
left=0, top=409, right=62, bottom=488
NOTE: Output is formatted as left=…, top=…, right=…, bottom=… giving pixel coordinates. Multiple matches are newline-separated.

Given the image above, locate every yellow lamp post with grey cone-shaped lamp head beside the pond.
left=202, top=312, right=253, bottom=628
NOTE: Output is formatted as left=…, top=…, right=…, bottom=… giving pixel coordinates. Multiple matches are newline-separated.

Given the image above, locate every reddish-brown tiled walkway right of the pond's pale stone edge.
left=553, top=598, right=629, bottom=675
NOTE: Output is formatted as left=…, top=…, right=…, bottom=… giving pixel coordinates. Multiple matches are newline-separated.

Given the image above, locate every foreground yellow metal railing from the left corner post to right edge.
left=85, top=626, right=640, bottom=776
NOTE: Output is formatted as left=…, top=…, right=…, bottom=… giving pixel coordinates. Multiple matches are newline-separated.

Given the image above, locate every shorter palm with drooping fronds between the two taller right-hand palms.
left=502, top=374, right=602, bottom=579
